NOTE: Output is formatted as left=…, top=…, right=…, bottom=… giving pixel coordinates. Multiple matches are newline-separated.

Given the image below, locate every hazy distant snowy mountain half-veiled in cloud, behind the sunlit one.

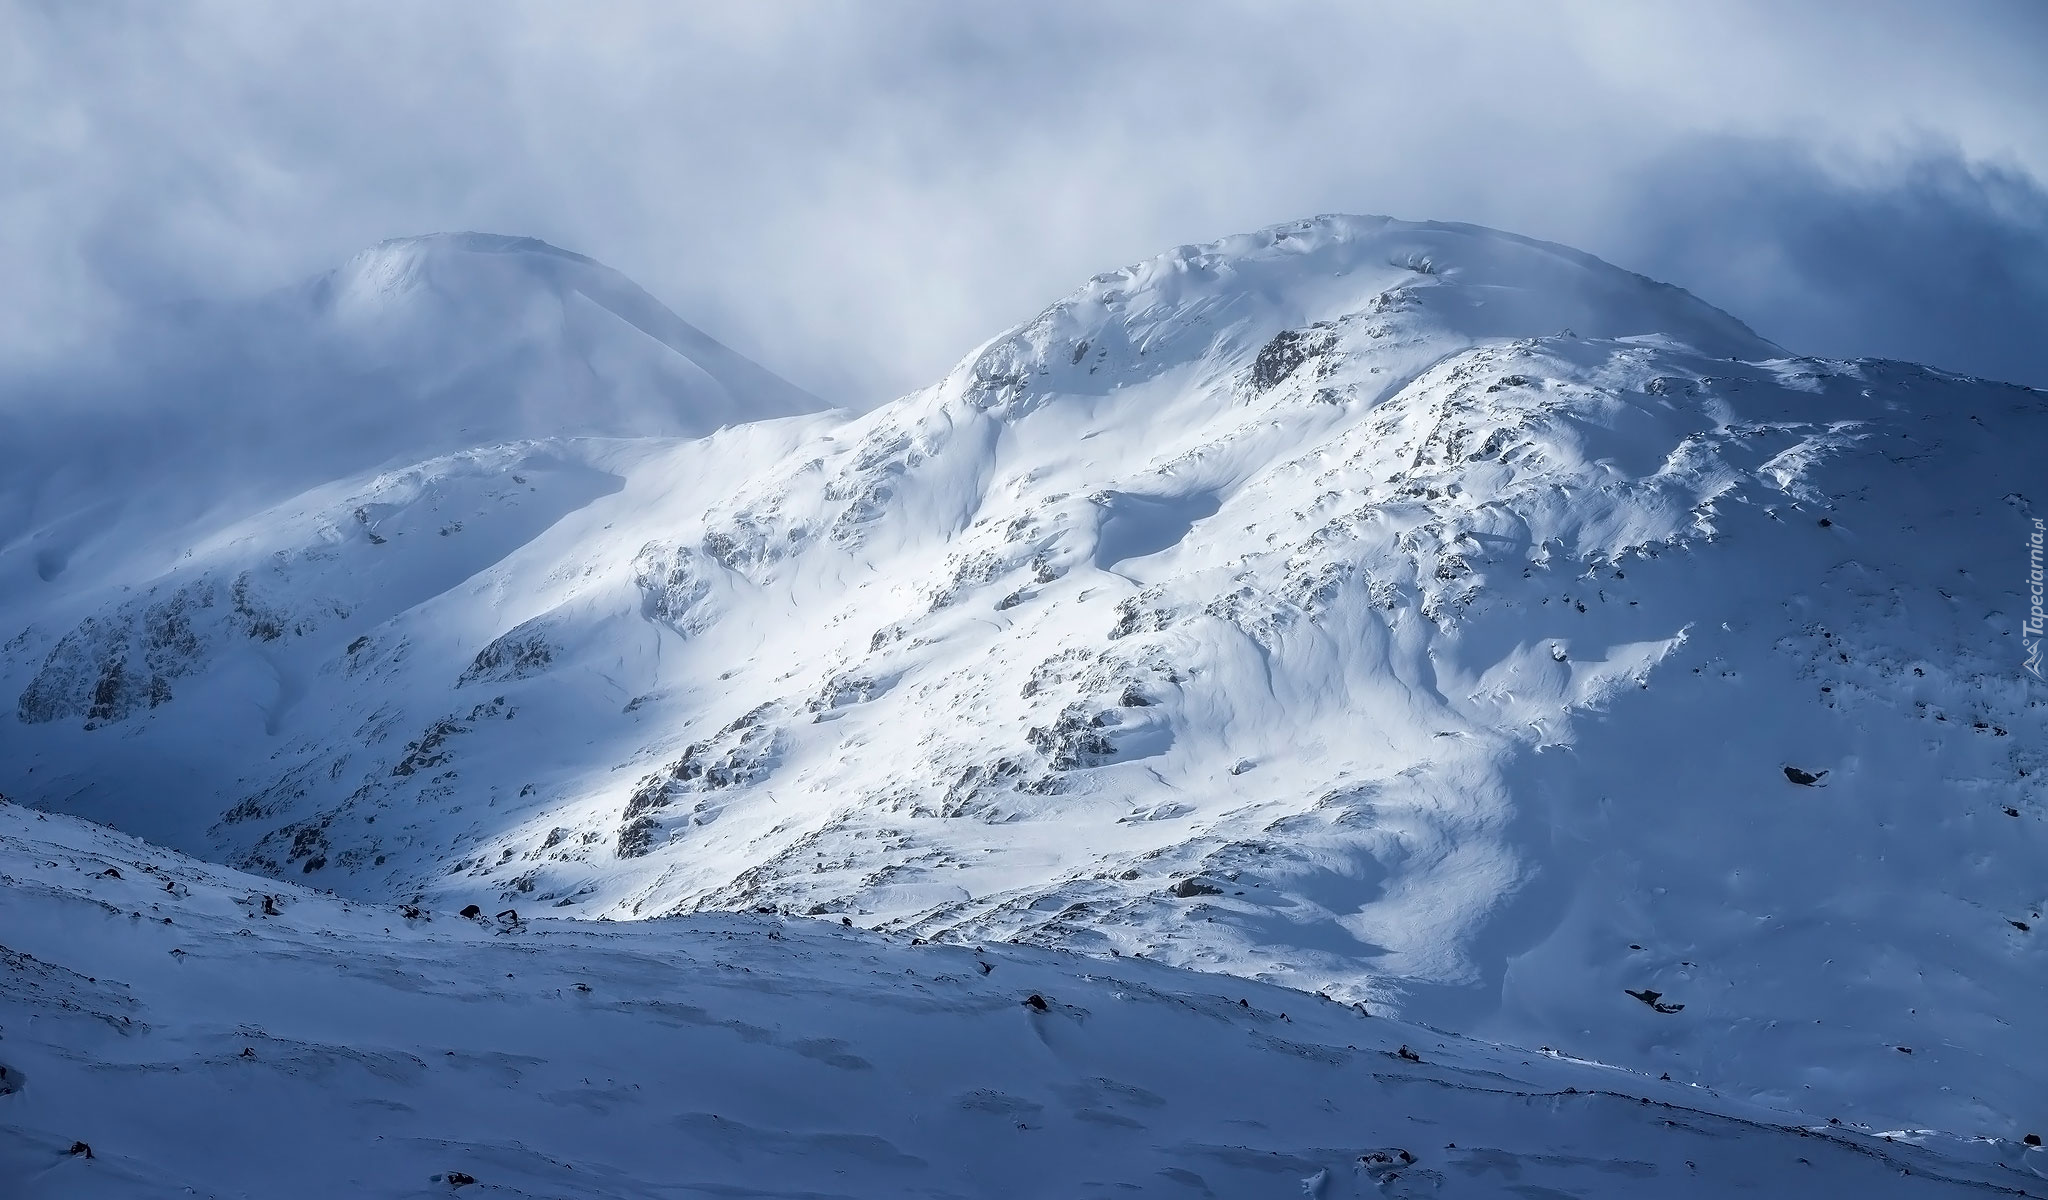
left=0, top=233, right=823, bottom=604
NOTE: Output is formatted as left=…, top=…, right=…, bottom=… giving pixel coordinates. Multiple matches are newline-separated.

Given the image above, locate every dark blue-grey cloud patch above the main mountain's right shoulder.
left=1589, top=141, right=2048, bottom=385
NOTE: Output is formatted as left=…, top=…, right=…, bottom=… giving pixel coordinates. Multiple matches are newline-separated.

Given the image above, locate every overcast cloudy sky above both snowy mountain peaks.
left=0, top=0, right=2048, bottom=405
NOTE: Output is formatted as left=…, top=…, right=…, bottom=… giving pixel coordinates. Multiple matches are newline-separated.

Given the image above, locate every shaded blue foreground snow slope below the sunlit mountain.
left=0, top=805, right=2048, bottom=1200
